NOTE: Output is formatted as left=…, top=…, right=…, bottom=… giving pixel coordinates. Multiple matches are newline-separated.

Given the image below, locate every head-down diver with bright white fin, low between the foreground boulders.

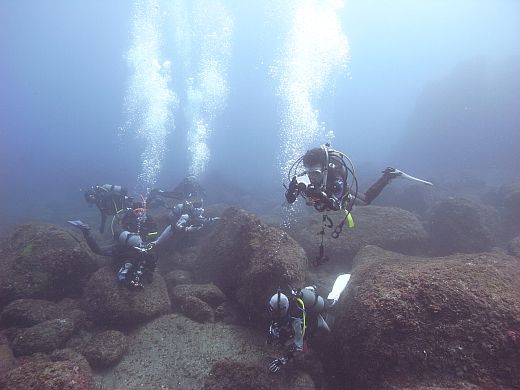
left=267, top=274, right=350, bottom=372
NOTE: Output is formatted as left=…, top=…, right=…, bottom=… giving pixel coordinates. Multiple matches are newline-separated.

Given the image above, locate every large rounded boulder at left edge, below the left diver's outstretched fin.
left=0, top=223, right=97, bottom=309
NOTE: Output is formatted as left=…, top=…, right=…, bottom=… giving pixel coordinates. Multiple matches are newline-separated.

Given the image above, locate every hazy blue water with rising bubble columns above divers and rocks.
left=0, top=0, right=520, bottom=231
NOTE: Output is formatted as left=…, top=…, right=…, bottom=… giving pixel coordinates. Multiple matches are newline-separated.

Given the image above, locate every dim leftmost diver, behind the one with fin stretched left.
left=84, top=184, right=131, bottom=233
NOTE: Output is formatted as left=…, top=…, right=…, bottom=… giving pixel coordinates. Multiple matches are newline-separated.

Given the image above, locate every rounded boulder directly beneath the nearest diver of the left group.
left=83, top=267, right=171, bottom=327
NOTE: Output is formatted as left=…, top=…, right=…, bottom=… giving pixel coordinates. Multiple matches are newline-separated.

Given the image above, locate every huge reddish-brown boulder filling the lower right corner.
left=331, top=246, right=520, bottom=389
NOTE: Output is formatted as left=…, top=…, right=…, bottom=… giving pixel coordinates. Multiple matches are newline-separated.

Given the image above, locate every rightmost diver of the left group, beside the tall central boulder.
left=154, top=197, right=220, bottom=246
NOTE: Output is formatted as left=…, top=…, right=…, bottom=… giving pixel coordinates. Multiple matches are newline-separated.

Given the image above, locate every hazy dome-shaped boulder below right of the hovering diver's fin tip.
left=429, top=198, right=500, bottom=255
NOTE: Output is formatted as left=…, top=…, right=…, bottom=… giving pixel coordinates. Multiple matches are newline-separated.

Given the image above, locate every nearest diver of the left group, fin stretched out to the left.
left=68, top=202, right=158, bottom=289
